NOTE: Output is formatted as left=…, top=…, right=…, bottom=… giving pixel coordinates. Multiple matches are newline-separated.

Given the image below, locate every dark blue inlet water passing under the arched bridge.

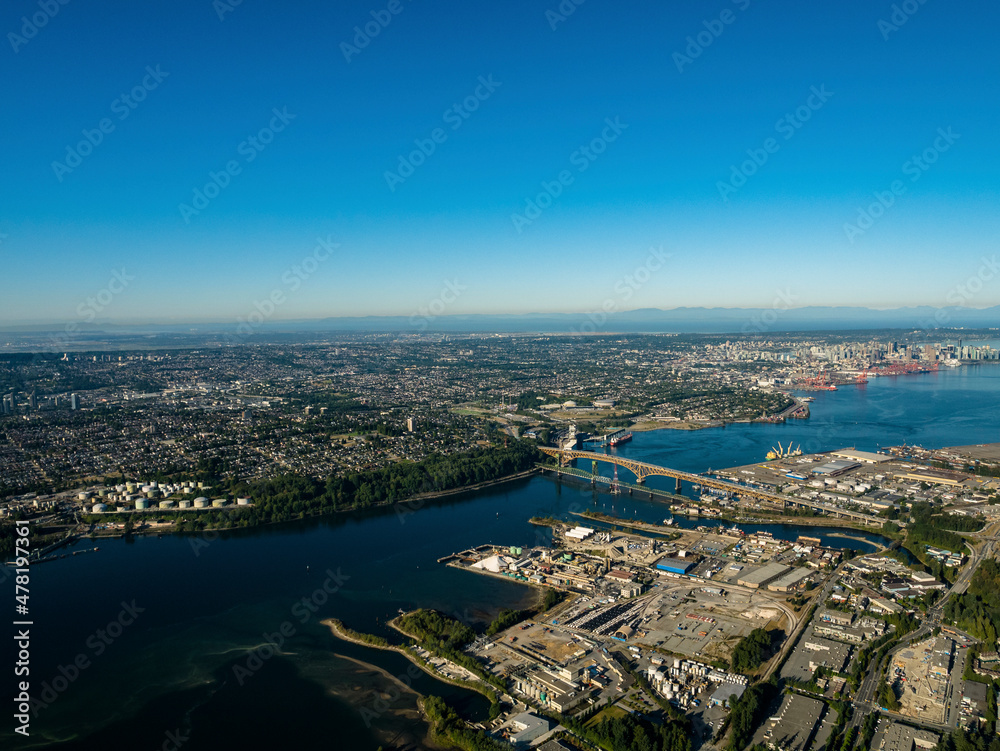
left=0, top=365, right=1000, bottom=751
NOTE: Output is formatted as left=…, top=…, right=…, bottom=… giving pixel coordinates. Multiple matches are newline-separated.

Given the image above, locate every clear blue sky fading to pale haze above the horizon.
left=0, top=0, right=1000, bottom=323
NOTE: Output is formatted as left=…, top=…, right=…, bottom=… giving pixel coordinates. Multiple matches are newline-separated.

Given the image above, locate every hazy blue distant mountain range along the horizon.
left=0, top=305, right=1000, bottom=338
